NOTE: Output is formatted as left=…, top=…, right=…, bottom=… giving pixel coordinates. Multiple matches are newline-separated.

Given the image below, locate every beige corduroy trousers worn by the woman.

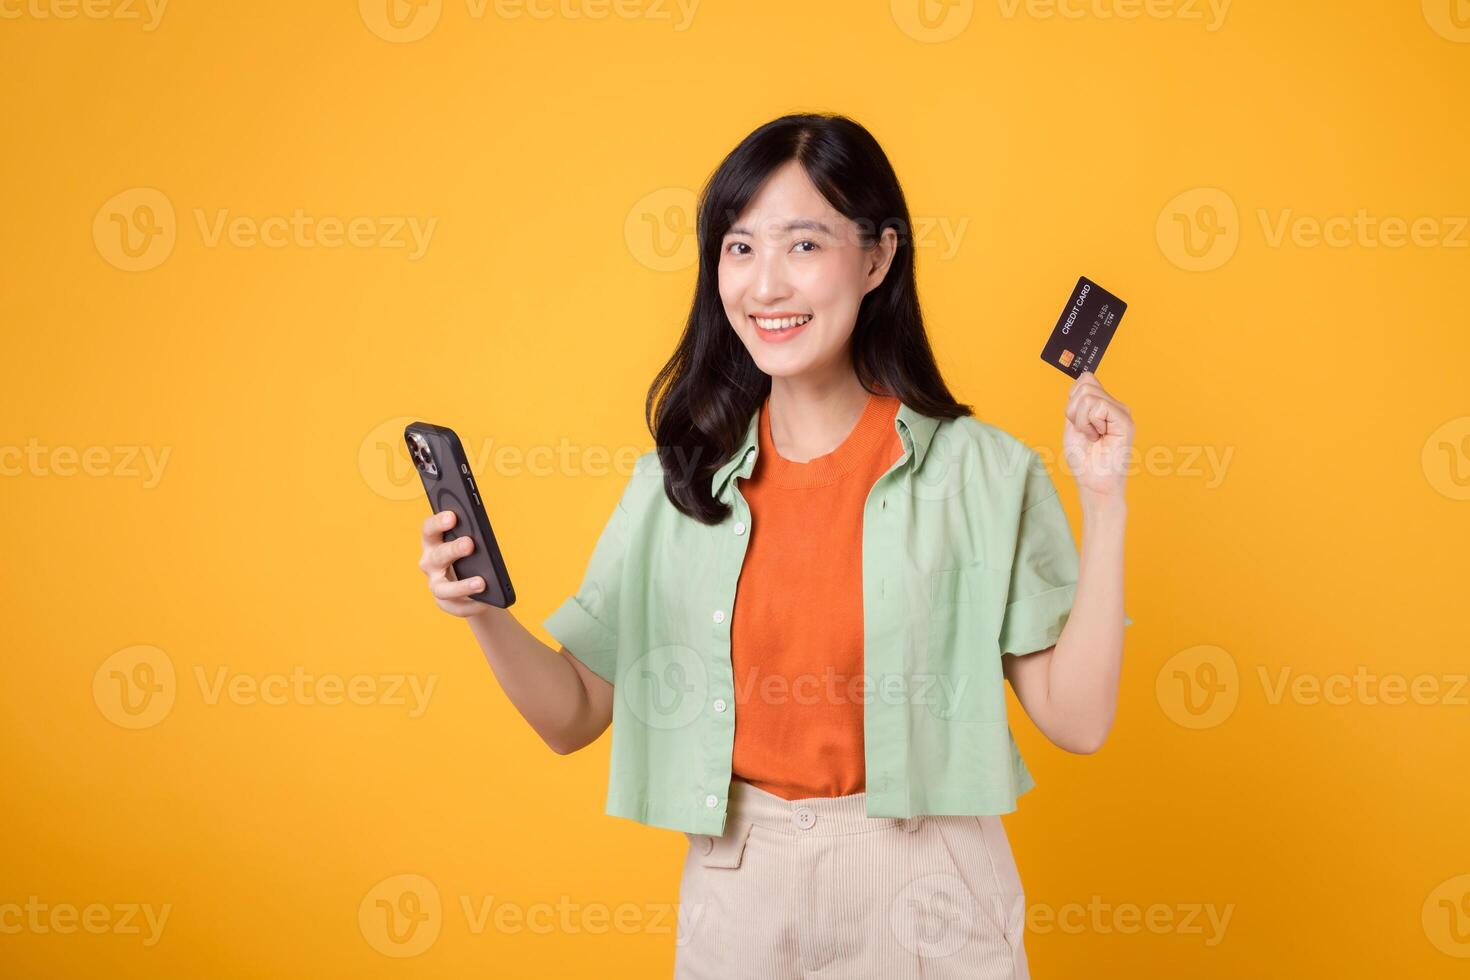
left=673, top=779, right=1029, bottom=980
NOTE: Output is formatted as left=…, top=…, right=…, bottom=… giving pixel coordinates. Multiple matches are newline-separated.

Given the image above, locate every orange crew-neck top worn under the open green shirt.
left=731, top=395, right=903, bottom=799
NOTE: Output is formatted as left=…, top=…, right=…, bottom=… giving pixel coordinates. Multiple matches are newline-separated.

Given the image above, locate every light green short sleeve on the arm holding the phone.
left=542, top=500, right=631, bottom=683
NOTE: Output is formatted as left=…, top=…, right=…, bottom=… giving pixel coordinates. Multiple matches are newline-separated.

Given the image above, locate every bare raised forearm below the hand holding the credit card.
left=1047, top=492, right=1127, bottom=751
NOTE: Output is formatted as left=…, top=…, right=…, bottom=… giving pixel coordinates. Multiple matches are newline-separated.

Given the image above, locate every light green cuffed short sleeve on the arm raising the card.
left=1000, top=450, right=1133, bottom=654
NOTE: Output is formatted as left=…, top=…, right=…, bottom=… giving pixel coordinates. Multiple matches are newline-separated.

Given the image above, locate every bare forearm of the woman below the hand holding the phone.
left=469, top=605, right=591, bottom=754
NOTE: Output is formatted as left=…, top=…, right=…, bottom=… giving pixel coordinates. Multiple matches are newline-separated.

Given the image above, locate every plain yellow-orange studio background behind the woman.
left=0, top=0, right=1470, bottom=979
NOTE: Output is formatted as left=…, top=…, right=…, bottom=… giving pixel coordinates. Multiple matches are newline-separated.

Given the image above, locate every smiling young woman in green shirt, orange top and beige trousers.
left=420, top=115, right=1133, bottom=980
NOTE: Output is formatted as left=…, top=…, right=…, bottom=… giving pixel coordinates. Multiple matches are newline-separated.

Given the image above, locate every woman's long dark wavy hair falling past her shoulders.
left=644, top=115, right=972, bottom=525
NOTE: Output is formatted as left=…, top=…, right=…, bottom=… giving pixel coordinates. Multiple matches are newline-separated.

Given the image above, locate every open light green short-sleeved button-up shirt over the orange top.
left=544, top=406, right=1132, bottom=835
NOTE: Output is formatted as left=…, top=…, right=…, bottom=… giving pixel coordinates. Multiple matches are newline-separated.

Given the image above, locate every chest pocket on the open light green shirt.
left=914, top=561, right=1010, bottom=723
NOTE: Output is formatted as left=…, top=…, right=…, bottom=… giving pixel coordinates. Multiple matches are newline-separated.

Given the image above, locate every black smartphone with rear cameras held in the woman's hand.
left=403, top=422, right=516, bottom=608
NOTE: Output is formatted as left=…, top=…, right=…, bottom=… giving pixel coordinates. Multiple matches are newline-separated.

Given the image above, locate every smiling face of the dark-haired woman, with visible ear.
left=719, top=160, right=897, bottom=378
